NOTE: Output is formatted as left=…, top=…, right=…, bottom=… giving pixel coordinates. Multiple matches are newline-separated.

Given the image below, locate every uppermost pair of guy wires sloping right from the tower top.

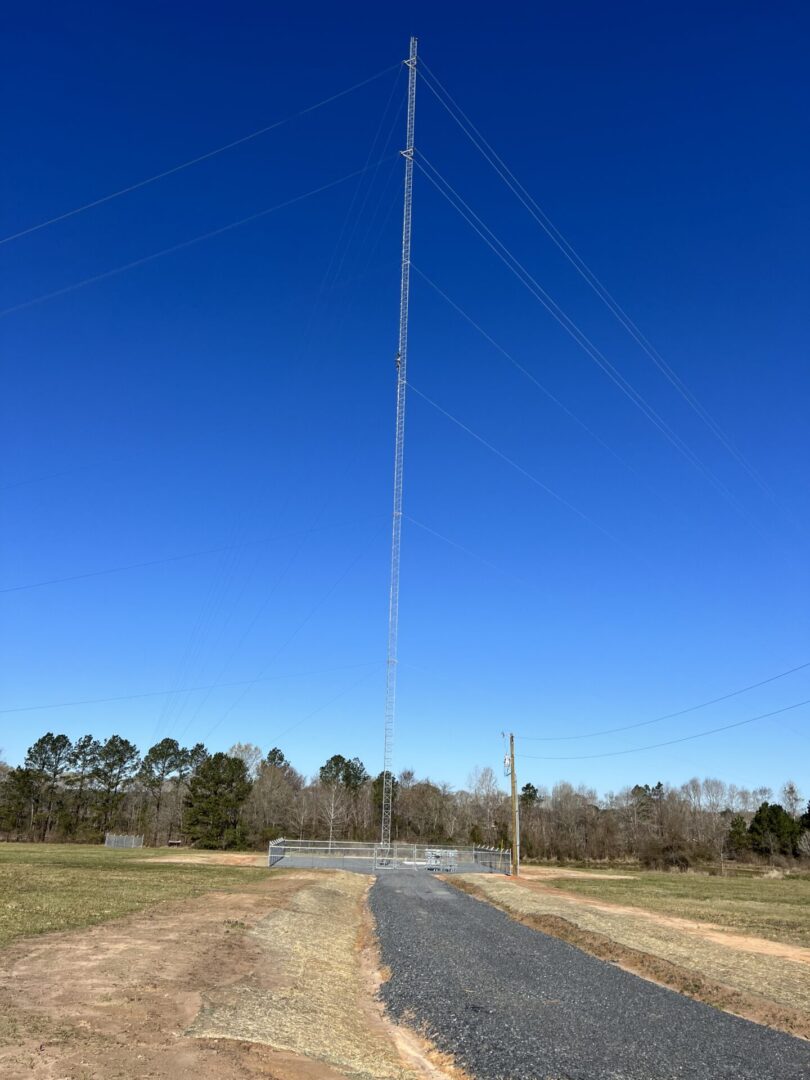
left=422, top=64, right=775, bottom=500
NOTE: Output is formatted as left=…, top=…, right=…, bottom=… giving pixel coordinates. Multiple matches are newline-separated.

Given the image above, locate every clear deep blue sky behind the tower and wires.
left=0, top=2, right=810, bottom=792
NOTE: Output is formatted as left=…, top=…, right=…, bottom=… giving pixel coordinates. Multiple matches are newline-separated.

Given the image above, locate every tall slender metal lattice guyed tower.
left=380, top=38, right=417, bottom=849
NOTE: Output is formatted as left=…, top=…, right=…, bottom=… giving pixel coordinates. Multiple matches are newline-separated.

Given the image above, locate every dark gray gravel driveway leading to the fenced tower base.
left=370, top=872, right=810, bottom=1080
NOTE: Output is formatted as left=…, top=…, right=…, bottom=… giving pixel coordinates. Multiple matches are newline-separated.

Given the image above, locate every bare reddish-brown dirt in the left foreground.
left=0, top=877, right=338, bottom=1080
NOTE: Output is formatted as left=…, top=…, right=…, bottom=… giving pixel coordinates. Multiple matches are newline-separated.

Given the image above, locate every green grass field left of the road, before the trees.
left=0, top=843, right=270, bottom=948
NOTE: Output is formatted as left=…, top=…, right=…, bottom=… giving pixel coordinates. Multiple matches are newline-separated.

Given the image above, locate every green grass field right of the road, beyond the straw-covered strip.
left=544, top=873, right=810, bottom=946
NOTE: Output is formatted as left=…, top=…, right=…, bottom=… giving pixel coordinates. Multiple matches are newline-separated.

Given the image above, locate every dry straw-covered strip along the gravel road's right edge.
left=448, top=875, right=810, bottom=1038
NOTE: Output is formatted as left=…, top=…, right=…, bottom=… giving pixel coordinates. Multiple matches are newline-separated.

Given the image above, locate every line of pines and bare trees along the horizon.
left=0, top=731, right=810, bottom=867
